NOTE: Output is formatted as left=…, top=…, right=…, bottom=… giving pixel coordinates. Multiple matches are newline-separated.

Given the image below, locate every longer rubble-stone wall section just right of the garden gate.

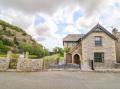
left=17, top=57, right=43, bottom=71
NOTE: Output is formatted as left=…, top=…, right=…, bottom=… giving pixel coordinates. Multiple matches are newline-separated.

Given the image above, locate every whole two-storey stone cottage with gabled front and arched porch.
left=63, top=24, right=120, bottom=70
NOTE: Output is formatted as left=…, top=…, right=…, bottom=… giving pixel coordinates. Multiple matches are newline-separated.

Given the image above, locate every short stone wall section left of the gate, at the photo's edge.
left=0, top=58, right=10, bottom=71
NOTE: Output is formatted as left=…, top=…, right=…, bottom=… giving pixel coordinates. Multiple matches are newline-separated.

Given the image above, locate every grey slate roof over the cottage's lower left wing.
left=63, top=34, right=84, bottom=41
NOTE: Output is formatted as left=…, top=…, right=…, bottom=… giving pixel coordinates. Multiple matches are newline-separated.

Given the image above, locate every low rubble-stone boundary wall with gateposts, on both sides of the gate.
left=0, top=52, right=43, bottom=72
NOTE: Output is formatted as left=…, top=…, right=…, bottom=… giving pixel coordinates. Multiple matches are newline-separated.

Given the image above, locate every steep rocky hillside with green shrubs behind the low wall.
left=0, top=20, right=47, bottom=57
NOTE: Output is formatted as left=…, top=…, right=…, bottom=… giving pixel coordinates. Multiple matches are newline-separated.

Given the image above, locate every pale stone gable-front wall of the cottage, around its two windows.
left=82, top=32, right=116, bottom=68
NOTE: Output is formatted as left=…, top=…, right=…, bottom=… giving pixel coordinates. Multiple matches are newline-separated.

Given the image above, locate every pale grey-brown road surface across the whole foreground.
left=0, top=71, right=120, bottom=89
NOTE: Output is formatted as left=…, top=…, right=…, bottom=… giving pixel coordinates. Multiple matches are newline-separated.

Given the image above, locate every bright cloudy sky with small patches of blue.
left=0, top=0, right=120, bottom=50
